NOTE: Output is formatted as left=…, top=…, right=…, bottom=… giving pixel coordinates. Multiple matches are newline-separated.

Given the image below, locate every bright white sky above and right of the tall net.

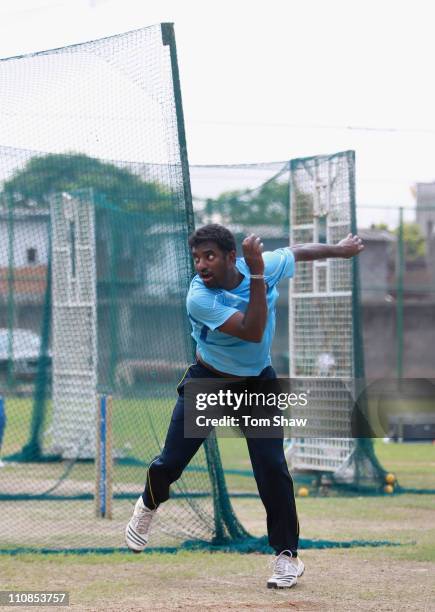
left=0, top=0, right=435, bottom=227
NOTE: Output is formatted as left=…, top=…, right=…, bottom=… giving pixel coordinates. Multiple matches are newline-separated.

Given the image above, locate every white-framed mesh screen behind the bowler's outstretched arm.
left=288, top=151, right=384, bottom=488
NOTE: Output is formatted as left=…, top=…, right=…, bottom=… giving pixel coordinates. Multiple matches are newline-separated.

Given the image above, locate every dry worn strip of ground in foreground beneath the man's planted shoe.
left=0, top=548, right=435, bottom=612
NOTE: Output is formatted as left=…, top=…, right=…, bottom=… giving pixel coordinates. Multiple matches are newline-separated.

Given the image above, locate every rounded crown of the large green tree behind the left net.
left=3, top=153, right=172, bottom=214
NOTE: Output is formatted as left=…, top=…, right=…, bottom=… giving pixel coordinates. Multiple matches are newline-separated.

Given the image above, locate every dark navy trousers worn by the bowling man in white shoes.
left=143, top=362, right=299, bottom=554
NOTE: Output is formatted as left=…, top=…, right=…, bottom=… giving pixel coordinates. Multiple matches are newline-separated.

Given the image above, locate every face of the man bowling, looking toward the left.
left=192, top=242, right=236, bottom=289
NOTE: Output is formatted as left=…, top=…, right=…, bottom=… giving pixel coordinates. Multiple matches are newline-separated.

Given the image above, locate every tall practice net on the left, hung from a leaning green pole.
left=0, top=24, right=246, bottom=549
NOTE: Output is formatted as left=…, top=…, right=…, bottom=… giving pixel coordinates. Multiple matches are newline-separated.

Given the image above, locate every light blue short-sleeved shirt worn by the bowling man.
left=186, top=247, right=295, bottom=376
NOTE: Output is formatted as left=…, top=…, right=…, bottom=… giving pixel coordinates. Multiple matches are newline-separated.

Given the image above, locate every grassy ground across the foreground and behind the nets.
left=0, top=399, right=435, bottom=612
